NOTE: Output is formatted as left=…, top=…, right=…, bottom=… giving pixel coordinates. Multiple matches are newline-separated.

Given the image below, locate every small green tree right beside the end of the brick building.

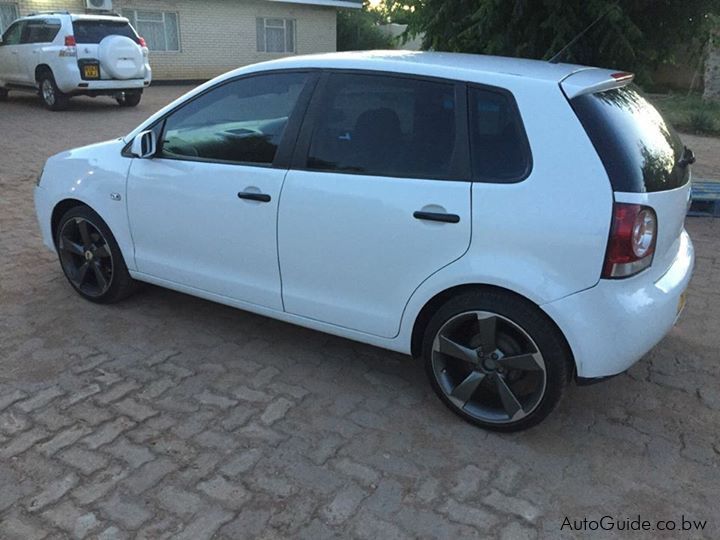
left=337, top=2, right=393, bottom=51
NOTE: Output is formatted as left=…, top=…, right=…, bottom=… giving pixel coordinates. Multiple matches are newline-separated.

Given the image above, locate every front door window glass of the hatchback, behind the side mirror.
left=161, top=73, right=307, bottom=164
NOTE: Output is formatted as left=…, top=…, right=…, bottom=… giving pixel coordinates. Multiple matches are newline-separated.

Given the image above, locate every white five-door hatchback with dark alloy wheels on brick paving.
left=35, top=51, right=694, bottom=431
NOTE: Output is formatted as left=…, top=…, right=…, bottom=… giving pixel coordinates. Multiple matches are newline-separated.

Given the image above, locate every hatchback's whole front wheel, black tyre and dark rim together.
left=55, top=206, right=137, bottom=304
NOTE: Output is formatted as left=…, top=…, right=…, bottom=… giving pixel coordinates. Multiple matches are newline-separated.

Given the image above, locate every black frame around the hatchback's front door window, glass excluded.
left=121, top=68, right=319, bottom=170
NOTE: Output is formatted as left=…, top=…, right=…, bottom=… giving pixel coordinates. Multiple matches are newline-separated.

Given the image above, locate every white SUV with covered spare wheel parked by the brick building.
left=0, top=12, right=152, bottom=111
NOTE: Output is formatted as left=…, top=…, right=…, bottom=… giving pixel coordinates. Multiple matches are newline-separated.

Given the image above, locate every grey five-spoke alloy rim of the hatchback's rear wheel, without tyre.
left=431, top=311, right=547, bottom=424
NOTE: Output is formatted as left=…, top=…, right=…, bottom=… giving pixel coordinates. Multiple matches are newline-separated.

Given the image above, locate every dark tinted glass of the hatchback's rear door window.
left=307, top=74, right=455, bottom=178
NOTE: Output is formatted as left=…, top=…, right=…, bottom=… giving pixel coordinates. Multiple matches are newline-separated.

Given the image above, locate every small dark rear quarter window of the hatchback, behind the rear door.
left=468, top=88, right=530, bottom=182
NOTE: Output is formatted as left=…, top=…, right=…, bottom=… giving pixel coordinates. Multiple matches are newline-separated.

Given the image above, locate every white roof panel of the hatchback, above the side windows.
left=246, top=50, right=597, bottom=82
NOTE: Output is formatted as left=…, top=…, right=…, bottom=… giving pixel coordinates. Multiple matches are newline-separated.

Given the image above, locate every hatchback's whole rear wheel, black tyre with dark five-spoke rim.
left=422, top=289, right=572, bottom=432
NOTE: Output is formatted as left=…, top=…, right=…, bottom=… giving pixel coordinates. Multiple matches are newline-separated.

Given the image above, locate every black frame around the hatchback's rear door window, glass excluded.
left=291, top=69, right=473, bottom=182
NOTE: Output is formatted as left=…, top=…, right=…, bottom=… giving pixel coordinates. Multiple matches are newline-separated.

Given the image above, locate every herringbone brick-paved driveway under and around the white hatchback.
left=0, top=87, right=720, bottom=539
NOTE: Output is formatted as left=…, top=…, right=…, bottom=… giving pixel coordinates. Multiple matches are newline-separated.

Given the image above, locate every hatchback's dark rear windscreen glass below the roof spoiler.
left=570, top=85, right=690, bottom=193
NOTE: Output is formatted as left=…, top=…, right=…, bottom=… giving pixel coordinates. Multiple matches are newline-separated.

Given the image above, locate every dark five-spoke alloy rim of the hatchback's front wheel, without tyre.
left=58, top=217, right=113, bottom=298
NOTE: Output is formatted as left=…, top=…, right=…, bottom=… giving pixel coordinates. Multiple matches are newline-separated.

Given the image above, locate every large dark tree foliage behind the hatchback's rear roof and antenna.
left=384, top=0, right=720, bottom=81
